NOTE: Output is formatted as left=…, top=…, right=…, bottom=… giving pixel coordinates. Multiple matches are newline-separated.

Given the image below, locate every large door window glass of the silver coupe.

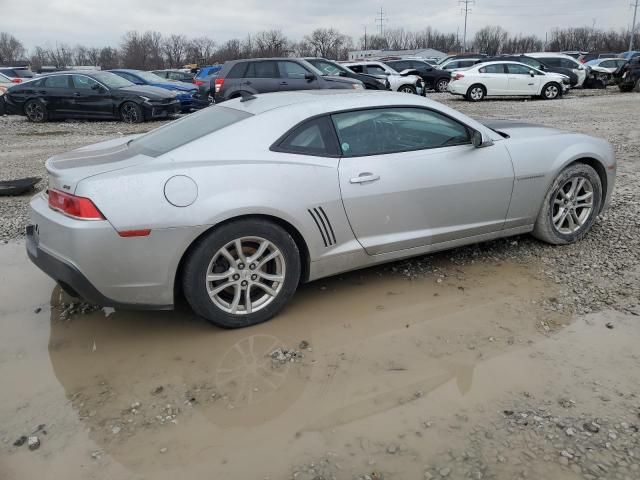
left=332, top=107, right=471, bottom=157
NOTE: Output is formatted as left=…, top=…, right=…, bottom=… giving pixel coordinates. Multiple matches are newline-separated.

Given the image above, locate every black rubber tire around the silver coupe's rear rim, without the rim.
left=182, top=219, right=301, bottom=328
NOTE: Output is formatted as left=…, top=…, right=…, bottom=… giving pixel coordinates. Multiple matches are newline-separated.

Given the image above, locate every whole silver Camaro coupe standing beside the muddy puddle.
left=27, top=91, right=616, bottom=328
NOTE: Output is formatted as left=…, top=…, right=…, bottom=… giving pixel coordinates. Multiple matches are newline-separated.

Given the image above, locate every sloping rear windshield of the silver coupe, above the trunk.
left=129, top=105, right=253, bottom=157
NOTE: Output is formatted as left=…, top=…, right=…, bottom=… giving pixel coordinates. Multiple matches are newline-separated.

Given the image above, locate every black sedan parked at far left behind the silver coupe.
left=5, top=71, right=180, bottom=123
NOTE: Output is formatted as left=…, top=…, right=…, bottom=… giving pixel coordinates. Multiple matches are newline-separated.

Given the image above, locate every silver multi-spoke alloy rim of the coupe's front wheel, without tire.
left=551, top=176, right=593, bottom=235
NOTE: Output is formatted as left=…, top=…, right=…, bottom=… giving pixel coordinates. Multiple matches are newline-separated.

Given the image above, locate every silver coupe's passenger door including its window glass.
left=332, top=107, right=514, bottom=255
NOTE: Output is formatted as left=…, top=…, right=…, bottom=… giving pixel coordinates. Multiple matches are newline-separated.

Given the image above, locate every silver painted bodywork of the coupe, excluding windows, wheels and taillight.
left=31, top=91, right=615, bottom=308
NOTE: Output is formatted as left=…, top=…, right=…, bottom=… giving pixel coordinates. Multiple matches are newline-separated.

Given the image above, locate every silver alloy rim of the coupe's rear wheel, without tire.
left=205, top=237, right=286, bottom=315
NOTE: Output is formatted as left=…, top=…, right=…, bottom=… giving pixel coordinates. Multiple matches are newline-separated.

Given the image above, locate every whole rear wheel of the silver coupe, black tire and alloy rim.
left=182, top=219, right=301, bottom=328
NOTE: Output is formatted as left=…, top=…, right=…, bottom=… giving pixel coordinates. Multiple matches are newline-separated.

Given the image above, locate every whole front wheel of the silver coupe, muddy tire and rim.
left=533, top=163, right=602, bottom=245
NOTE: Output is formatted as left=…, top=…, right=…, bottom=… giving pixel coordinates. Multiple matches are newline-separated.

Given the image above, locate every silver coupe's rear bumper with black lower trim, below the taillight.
left=27, top=194, right=206, bottom=309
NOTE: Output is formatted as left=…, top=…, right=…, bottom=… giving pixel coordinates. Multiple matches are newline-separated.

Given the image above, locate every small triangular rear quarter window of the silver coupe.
left=278, top=117, right=337, bottom=156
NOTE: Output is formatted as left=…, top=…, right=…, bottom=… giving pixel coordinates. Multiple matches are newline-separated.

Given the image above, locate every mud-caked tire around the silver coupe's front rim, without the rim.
left=533, top=163, right=603, bottom=245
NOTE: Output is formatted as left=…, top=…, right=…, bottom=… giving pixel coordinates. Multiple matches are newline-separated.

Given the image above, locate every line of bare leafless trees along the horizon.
left=0, top=26, right=640, bottom=70
